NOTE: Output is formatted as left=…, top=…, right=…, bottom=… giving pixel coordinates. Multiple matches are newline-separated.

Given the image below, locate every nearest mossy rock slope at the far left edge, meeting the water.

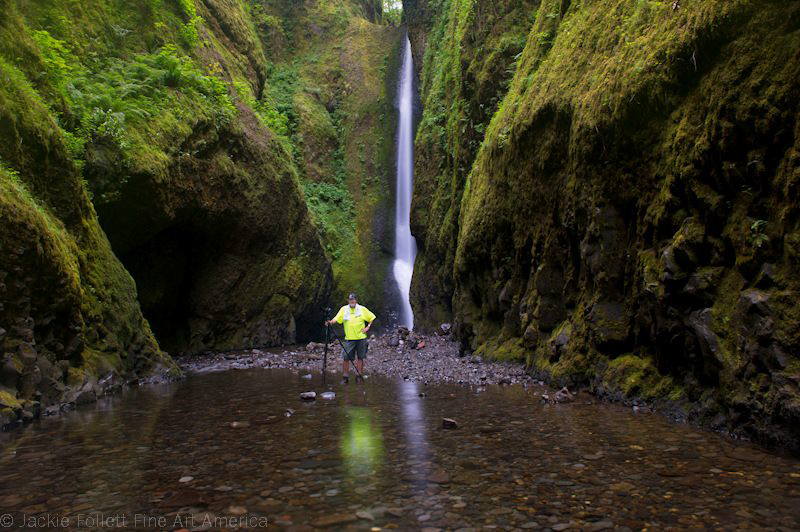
left=0, top=3, right=178, bottom=426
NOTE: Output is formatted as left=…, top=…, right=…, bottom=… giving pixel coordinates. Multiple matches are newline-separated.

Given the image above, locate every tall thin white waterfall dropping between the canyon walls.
left=394, top=37, right=417, bottom=329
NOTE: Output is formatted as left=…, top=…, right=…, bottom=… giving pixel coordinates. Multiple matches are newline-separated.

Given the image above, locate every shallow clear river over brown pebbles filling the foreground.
left=0, top=369, right=800, bottom=530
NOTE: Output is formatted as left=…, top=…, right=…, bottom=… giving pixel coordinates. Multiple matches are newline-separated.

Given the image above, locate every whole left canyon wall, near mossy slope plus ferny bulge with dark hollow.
left=0, top=0, right=332, bottom=416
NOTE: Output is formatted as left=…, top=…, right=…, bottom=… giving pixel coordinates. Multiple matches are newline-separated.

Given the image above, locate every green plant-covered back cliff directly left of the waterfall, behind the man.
left=250, top=0, right=404, bottom=326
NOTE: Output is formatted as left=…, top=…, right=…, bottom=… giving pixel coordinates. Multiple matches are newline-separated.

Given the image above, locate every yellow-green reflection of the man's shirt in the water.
left=340, top=406, right=383, bottom=477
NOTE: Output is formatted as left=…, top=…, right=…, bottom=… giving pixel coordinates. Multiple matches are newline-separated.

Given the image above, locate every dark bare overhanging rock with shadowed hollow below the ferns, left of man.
left=90, top=104, right=331, bottom=351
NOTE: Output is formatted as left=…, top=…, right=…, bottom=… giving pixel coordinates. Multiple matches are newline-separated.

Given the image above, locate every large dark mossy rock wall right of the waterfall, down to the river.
left=407, top=0, right=800, bottom=452
